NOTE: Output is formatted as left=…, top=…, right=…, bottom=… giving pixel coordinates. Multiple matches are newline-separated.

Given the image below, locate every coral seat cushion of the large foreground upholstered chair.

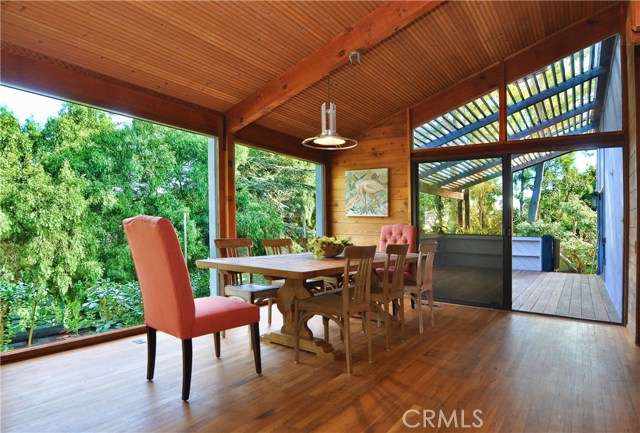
left=192, top=296, right=260, bottom=337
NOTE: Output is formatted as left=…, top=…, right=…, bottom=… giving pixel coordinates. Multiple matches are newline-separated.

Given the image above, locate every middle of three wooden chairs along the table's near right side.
left=371, top=244, right=409, bottom=350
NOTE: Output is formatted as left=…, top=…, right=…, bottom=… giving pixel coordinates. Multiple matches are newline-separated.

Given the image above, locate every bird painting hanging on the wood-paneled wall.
left=345, top=168, right=389, bottom=216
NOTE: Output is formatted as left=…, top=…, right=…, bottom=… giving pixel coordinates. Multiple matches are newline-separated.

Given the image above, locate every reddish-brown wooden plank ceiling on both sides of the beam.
left=1, top=1, right=612, bottom=137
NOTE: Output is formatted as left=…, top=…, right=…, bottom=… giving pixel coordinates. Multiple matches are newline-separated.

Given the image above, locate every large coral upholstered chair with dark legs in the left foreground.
left=122, top=215, right=262, bottom=401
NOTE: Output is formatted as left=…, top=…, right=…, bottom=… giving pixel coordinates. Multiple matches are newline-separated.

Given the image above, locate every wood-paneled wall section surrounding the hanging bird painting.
left=327, top=112, right=411, bottom=245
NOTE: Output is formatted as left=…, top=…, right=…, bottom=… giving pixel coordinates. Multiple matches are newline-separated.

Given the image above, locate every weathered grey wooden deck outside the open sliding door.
left=512, top=271, right=621, bottom=323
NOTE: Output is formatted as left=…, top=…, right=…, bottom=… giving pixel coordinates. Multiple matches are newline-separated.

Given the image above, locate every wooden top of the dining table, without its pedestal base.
left=196, top=253, right=418, bottom=279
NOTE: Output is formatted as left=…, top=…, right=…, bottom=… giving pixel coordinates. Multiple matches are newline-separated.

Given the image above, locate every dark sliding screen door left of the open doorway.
left=416, top=158, right=505, bottom=308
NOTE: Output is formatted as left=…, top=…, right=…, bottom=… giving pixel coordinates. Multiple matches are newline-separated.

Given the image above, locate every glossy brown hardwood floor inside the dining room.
left=0, top=303, right=640, bottom=433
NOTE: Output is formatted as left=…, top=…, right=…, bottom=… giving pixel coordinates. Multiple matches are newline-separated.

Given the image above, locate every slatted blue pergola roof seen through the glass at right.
left=413, top=37, right=620, bottom=196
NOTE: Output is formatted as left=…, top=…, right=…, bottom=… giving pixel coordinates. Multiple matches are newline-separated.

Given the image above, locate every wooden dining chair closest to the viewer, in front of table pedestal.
left=294, top=246, right=376, bottom=374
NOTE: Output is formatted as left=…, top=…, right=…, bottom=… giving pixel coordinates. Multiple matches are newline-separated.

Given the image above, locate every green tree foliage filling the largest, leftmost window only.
left=0, top=104, right=209, bottom=346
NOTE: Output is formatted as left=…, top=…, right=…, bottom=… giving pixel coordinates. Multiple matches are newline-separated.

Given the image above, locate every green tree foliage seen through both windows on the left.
left=0, top=99, right=315, bottom=347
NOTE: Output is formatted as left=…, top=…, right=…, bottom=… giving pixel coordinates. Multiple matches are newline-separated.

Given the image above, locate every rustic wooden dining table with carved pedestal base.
left=196, top=252, right=418, bottom=359
